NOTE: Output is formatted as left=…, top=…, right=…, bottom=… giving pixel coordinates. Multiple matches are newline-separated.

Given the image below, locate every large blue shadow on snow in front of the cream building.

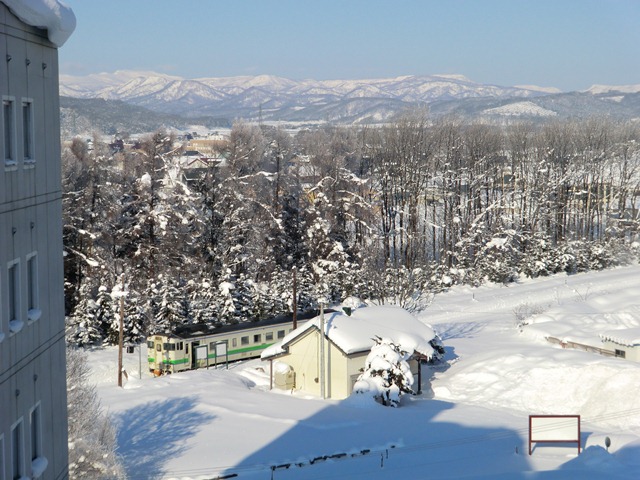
left=220, top=362, right=529, bottom=480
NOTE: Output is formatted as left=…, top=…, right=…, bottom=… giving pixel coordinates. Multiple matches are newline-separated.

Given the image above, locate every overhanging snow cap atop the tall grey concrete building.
left=0, top=0, right=76, bottom=47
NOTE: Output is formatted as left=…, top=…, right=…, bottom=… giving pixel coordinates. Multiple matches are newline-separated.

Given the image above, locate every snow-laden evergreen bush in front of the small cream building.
left=353, top=337, right=413, bottom=407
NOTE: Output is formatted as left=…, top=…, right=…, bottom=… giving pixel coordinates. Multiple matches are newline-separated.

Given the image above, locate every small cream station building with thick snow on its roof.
left=262, top=306, right=442, bottom=399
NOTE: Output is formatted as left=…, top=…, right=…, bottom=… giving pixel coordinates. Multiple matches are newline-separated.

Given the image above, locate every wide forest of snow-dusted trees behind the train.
left=63, top=115, right=640, bottom=344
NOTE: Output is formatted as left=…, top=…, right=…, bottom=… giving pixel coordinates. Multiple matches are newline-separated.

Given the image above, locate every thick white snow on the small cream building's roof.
left=262, top=306, right=436, bottom=359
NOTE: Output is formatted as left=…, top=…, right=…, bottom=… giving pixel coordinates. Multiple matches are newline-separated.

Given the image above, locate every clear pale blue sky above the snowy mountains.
left=60, top=0, right=640, bottom=91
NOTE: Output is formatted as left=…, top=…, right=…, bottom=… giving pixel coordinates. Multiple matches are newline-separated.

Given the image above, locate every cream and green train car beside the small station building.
left=147, top=312, right=318, bottom=375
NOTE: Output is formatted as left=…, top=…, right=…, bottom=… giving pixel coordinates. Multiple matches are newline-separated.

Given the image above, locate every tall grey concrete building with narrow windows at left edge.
left=0, top=0, right=75, bottom=480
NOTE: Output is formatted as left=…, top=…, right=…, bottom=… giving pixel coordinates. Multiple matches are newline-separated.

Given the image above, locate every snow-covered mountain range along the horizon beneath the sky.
left=60, top=71, right=640, bottom=133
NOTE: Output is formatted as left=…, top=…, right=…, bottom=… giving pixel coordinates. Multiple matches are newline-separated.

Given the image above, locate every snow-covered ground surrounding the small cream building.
left=89, top=266, right=640, bottom=480
